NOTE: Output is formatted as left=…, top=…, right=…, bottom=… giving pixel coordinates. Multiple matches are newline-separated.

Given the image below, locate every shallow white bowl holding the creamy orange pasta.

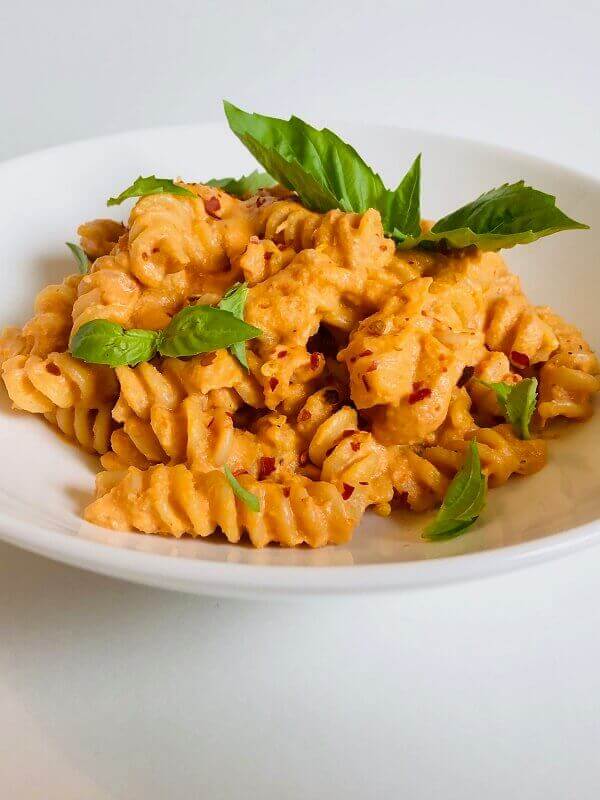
left=0, top=120, right=600, bottom=596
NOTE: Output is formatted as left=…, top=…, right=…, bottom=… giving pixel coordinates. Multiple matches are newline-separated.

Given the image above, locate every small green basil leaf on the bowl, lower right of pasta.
left=423, top=441, right=487, bottom=541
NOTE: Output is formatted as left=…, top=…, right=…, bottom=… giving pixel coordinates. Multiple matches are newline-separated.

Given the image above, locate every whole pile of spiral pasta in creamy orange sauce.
left=0, top=184, right=600, bottom=547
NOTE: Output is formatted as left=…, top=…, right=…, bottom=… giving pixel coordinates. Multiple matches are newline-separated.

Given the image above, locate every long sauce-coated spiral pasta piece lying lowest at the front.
left=85, top=465, right=364, bottom=547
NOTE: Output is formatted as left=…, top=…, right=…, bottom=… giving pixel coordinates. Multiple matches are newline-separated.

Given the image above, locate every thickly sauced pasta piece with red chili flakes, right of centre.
left=338, top=278, right=485, bottom=444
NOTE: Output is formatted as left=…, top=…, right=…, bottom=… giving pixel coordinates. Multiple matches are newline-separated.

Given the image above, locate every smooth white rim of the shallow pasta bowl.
left=0, top=119, right=600, bottom=597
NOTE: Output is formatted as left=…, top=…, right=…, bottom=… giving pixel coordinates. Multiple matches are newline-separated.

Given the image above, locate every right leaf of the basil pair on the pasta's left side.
left=158, top=306, right=262, bottom=357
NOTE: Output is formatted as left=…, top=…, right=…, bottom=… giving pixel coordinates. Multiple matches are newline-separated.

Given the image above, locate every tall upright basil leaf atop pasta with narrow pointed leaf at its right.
left=224, top=101, right=420, bottom=238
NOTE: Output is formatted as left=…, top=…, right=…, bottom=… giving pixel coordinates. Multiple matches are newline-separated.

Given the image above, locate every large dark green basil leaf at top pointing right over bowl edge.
left=400, top=181, right=589, bottom=250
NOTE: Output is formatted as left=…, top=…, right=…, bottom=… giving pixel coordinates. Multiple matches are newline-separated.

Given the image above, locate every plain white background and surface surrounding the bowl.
left=0, top=0, right=600, bottom=800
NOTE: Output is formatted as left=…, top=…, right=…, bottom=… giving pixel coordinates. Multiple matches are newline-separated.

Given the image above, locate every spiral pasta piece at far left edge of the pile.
left=2, top=353, right=117, bottom=414
